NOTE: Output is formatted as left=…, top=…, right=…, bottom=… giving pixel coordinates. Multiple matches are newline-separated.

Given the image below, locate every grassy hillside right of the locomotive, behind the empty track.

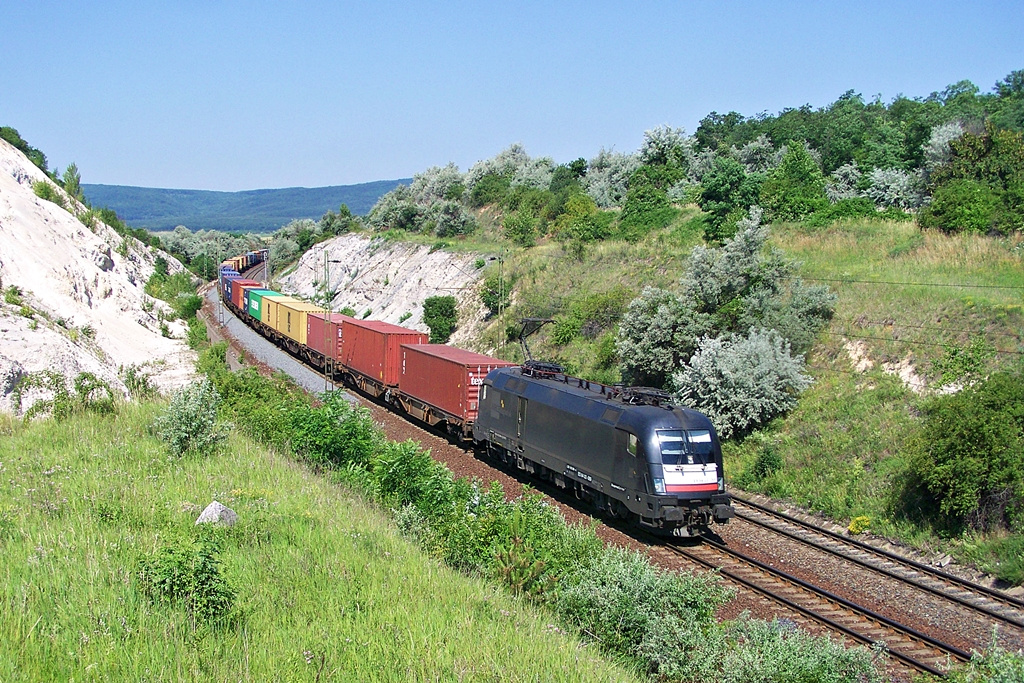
left=741, top=221, right=1024, bottom=578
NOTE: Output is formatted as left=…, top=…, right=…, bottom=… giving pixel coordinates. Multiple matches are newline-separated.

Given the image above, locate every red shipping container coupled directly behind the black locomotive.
left=398, top=344, right=519, bottom=424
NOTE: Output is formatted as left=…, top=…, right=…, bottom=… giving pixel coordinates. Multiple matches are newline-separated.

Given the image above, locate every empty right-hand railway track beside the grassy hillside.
left=732, top=496, right=1024, bottom=631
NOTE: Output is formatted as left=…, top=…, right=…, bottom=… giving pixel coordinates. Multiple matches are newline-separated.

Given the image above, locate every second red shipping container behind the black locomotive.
left=340, top=317, right=427, bottom=386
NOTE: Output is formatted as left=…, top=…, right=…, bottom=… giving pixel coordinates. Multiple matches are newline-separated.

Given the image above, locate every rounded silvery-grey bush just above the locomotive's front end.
left=674, top=330, right=811, bottom=438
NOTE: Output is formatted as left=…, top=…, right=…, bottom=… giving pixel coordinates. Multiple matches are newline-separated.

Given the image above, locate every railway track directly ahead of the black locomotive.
left=669, top=539, right=971, bottom=676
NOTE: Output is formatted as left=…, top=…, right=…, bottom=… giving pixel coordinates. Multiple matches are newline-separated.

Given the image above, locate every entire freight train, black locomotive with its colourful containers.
left=218, top=250, right=733, bottom=537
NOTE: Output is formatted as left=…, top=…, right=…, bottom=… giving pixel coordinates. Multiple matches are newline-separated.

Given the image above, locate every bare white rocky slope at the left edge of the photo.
left=0, top=140, right=195, bottom=411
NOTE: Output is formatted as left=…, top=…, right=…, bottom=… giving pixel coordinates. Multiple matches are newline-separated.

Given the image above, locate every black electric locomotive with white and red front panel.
left=473, top=361, right=733, bottom=537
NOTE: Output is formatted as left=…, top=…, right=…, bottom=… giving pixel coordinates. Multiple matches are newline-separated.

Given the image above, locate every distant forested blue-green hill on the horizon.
left=82, top=178, right=411, bottom=232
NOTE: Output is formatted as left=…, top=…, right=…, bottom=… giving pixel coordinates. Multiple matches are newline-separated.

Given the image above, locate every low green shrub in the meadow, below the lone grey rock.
left=137, top=533, right=236, bottom=624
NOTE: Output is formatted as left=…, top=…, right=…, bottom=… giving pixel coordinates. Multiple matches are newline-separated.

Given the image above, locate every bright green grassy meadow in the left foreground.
left=0, top=404, right=631, bottom=681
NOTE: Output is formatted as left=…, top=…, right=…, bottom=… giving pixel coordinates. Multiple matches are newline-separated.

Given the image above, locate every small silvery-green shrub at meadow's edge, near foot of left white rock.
left=155, top=378, right=227, bottom=456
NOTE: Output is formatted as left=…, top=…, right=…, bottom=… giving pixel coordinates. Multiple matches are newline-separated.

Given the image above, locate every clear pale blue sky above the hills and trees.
left=0, top=0, right=1024, bottom=190
